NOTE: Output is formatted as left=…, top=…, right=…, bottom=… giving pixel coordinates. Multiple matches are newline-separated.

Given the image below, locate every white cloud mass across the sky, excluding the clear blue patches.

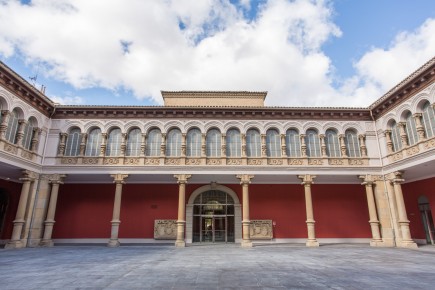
left=0, top=0, right=435, bottom=106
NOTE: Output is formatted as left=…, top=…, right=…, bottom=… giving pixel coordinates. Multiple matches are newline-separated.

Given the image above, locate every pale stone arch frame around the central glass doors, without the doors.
left=186, top=182, right=242, bottom=244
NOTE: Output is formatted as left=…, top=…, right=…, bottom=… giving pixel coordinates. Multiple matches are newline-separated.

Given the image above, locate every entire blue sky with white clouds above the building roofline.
left=0, top=0, right=435, bottom=106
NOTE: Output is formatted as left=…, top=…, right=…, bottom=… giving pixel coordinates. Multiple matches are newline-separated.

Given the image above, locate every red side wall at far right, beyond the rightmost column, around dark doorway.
left=402, top=178, right=435, bottom=239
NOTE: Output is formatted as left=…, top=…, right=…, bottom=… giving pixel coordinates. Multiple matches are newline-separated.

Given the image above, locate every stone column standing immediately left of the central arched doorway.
left=174, top=174, right=192, bottom=248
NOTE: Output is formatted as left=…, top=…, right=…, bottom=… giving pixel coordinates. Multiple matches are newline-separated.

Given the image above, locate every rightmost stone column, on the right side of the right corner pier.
left=391, top=171, right=417, bottom=248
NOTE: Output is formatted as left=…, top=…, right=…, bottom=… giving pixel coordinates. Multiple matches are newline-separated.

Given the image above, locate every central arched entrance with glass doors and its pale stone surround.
left=186, top=183, right=242, bottom=243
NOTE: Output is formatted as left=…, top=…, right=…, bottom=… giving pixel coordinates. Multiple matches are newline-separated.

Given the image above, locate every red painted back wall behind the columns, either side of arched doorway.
left=53, top=184, right=370, bottom=239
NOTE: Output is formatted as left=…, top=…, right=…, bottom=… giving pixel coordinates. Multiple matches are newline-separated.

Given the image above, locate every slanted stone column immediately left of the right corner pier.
left=359, top=174, right=383, bottom=246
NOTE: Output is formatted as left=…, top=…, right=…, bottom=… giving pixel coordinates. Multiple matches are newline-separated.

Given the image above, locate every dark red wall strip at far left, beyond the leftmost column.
left=0, top=180, right=22, bottom=240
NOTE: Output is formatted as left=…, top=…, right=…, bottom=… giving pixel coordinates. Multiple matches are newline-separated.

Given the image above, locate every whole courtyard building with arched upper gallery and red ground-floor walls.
left=0, top=58, right=435, bottom=248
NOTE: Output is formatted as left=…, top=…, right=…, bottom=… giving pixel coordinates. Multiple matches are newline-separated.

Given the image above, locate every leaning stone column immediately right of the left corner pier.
left=41, top=174, right=66, bottom=247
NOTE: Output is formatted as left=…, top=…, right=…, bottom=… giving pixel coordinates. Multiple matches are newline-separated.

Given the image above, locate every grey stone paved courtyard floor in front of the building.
left=0, top=245, right=435, bottom=289
